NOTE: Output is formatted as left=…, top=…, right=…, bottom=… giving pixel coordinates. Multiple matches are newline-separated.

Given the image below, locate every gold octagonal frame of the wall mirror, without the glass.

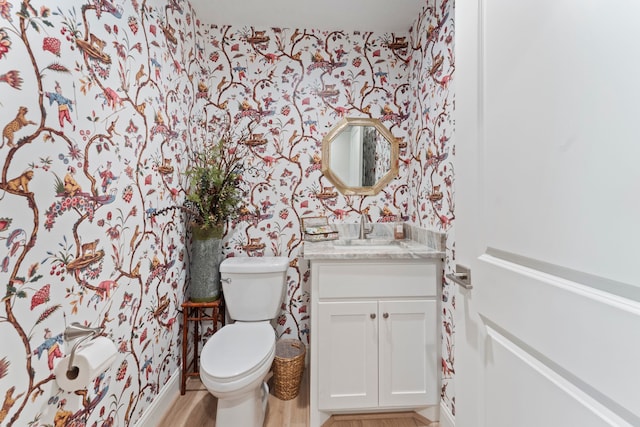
left=322, top=117, right=399, bottom=196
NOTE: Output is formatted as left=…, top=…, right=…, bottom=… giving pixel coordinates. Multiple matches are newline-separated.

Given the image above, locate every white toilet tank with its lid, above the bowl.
left=220, top=256, right=289, bottom=322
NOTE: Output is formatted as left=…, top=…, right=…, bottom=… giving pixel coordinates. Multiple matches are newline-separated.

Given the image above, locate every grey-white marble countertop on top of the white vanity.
left=300, top=227, right=444, bottom=260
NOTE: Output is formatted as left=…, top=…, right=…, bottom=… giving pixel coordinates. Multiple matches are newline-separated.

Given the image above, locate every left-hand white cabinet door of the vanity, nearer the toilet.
left=315, top=301, right=378, bottom=410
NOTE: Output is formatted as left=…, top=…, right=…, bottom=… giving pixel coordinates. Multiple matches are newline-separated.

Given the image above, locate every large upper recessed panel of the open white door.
left=481, top=0, right=640, bottom=286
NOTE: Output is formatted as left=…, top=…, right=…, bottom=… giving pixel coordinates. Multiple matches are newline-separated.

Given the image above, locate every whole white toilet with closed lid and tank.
left=200, top=257, right=289, bottom=427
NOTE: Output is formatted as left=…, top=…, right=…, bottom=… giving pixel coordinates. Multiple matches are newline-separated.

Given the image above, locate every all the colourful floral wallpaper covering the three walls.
left=0, top=0, right=455, bottom=426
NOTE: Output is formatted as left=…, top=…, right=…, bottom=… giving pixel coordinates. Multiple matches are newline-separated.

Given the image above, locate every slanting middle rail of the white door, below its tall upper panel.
left=475, top=255, right=640, bottom=425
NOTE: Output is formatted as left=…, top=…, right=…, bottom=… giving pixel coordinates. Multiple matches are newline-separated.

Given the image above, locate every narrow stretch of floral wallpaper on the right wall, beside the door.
left=401, top=0, right=455, bottom=415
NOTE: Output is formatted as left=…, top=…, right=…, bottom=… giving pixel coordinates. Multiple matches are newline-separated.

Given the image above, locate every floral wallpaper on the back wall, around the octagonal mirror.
left=202, top=26, right=410, bottom=342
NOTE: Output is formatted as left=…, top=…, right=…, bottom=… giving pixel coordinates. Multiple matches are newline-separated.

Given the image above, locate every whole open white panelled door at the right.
left=455, top=0, right=640, bottom=427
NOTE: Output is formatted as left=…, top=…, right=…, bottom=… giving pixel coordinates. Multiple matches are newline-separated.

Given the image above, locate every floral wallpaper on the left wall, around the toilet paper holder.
left=0, top=0, right=203, bottom=426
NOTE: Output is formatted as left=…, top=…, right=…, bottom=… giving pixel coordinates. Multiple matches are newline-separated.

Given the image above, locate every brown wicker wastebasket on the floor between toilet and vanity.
left=273, top=339, right=306, bottom=400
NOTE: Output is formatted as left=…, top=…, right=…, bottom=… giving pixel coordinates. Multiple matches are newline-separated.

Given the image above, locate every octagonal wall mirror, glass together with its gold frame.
left=322, top=117, right=398, bottom=195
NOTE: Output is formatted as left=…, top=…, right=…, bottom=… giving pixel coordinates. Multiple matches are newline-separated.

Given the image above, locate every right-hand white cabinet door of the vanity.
left=379, top=300, right=440, bottom=407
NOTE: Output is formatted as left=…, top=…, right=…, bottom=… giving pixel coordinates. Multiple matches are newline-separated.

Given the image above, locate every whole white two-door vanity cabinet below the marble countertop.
left=310, top=259, right=441, bottom=427
